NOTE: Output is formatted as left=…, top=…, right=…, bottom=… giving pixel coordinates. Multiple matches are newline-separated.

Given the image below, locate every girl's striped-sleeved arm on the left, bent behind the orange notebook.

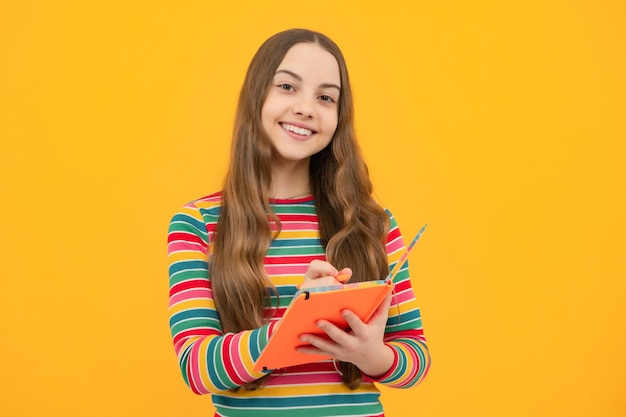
left=168, top=204, right=274, bottom=394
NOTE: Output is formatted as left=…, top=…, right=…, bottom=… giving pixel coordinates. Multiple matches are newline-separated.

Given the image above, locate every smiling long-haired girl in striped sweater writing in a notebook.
left=168, top=29, right=430, bottom=417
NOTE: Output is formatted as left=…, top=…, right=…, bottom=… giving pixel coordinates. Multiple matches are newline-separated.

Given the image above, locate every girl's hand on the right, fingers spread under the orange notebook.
left=298, top=294, right=394, bottom=377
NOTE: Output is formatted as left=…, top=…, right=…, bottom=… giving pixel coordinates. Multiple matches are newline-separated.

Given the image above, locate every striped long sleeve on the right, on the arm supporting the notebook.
left=377, top=213, right=430, bottom=388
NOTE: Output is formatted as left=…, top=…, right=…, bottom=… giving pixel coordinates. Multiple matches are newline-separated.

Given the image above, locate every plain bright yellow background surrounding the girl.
left=0, top=0, right=626, bottom=417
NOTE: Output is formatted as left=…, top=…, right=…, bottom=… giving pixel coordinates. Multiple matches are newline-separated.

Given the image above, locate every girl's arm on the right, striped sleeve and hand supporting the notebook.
left=298, top=216, right=430, bottom=388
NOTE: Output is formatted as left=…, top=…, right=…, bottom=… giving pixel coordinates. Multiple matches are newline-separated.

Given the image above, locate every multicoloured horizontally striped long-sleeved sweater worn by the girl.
left=168, top=193, right=430, bottom=417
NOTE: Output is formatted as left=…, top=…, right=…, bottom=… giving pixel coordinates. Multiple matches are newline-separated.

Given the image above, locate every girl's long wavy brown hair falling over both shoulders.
left=211, top=29, right=389, bottom=389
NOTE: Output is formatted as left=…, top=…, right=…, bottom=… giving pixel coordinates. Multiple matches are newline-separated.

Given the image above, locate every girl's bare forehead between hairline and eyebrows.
left=276, top=42, right=341, bottom=85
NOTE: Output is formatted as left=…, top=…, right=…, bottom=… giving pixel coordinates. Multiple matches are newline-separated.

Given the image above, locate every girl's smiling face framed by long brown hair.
left=261, top=42, right=341, bottom=169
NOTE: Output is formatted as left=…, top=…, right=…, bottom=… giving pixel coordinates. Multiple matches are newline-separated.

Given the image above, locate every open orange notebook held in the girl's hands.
left=254, top=225, right=427, bottom=372
